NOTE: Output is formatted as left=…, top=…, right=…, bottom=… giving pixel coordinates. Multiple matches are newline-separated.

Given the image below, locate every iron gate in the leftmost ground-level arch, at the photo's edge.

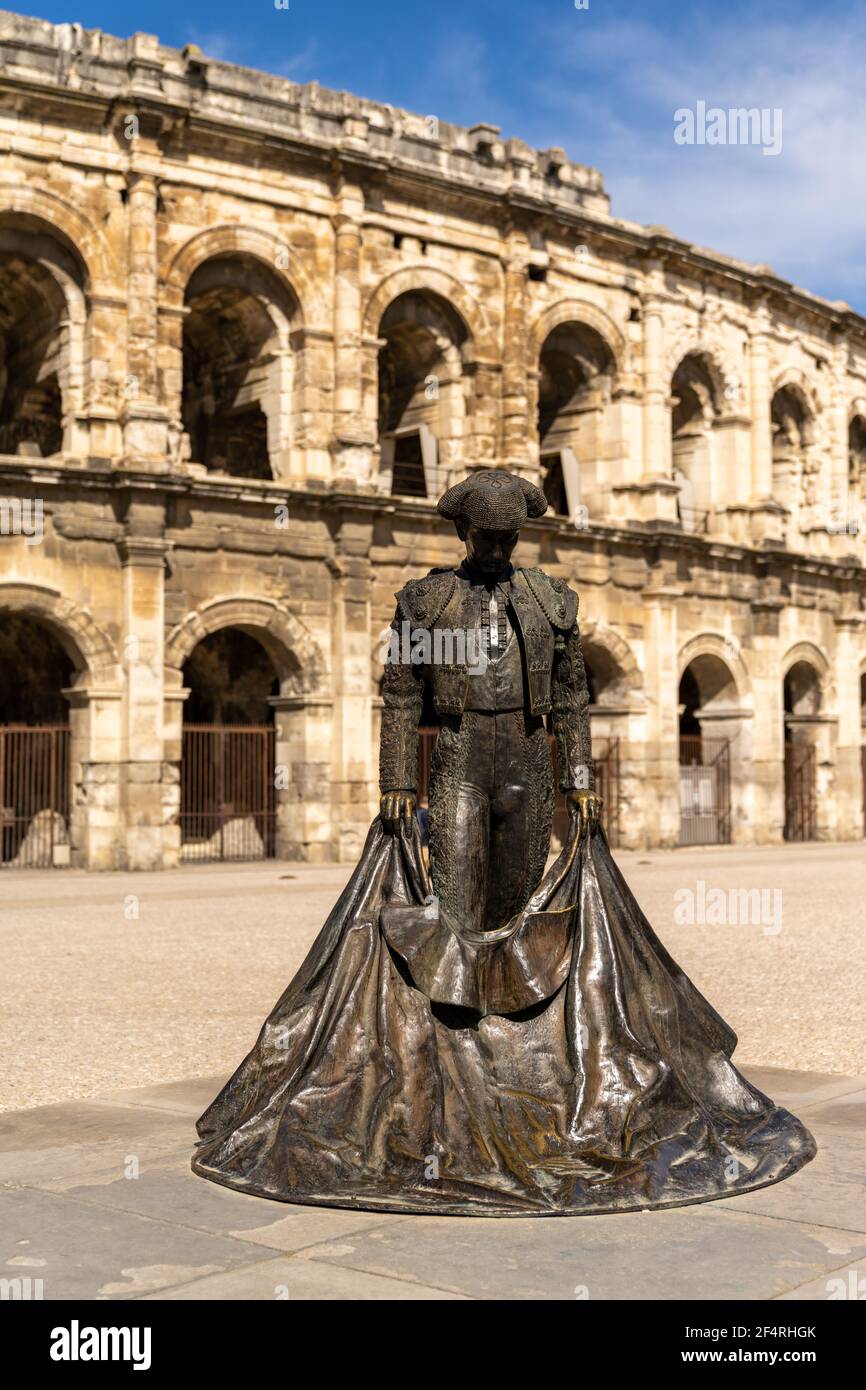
left=0, top=724, right=70, bottom=869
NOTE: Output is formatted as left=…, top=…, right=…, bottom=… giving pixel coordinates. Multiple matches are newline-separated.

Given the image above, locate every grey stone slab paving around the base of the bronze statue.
left=0, top=1068, right=866, bottom=1301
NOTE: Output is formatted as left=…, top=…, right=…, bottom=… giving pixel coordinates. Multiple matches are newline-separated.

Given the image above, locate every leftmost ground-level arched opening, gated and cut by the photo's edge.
left=0, top=613, right=75, bottom=869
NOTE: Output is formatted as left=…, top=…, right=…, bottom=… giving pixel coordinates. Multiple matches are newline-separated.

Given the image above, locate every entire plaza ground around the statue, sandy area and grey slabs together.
left=0, top=845, right=866, bottom=1300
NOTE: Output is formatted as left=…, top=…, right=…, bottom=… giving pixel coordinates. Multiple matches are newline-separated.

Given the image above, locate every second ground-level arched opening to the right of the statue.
left=680, top=652, right=745, bottom=845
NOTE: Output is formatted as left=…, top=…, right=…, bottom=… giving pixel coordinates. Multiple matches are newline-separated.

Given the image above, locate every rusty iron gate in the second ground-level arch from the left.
left=181, top=724, right=277, bottom=863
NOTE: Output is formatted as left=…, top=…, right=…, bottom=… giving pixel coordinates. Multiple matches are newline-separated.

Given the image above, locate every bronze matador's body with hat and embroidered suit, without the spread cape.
left=379, top=468, right=601, bottom=931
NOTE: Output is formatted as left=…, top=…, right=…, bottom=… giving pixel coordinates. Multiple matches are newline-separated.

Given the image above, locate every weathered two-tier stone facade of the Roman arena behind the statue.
left=0, top=13, right=866, bottom=869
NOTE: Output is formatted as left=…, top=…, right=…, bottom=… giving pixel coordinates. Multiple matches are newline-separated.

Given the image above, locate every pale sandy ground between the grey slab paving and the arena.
left=0, top=842, right=866, bottom=1109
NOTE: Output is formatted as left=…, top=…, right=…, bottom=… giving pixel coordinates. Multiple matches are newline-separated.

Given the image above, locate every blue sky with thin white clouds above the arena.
left=13, top=0, right=866, bottom=313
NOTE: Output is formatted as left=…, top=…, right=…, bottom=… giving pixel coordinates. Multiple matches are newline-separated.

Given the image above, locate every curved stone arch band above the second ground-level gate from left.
left=165, top=598, right=327, bottom=695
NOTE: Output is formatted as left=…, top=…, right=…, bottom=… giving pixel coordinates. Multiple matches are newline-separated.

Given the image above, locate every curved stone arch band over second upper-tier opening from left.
left=161, top=224, right=318, bottom=331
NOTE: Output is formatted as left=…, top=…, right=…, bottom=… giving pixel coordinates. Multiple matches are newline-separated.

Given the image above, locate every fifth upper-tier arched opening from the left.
left=671, top=352, right=720, bottom=534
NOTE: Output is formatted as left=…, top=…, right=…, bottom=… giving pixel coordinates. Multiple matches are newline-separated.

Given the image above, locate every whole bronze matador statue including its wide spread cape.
left=192, top=470, right=816, bottom=1216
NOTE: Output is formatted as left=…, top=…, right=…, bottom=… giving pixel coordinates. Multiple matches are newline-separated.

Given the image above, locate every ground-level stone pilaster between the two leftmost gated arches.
left=118, top=522, right=168, bottom=869
